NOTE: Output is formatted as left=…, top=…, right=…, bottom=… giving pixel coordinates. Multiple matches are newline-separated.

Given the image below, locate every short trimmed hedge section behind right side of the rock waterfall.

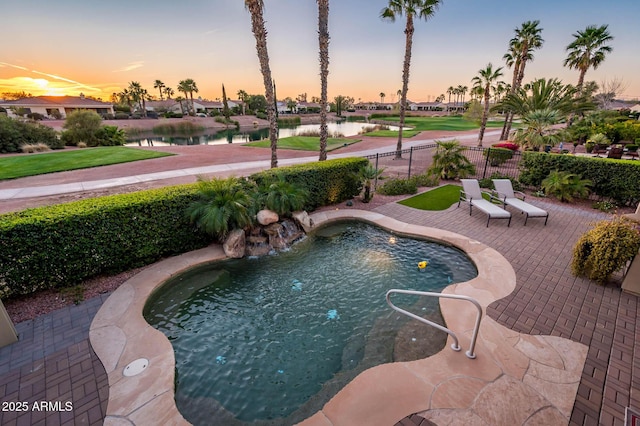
left=250, top=158, right=369, bottom=211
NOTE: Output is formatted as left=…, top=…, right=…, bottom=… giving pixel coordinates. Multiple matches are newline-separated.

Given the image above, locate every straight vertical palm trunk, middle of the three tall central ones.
left=318, top=0, right=329, bottom=161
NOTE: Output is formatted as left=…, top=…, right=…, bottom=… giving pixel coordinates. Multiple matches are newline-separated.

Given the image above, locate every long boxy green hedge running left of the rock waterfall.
left=0, top=185, right=210, bottom=298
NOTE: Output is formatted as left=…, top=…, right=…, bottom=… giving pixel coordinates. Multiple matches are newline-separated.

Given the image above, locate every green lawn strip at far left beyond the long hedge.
left=0, top=146, right=173, bottom=180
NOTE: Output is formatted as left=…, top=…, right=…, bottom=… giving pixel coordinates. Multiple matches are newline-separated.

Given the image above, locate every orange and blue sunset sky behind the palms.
left=0, top=0, right=640, bottom=102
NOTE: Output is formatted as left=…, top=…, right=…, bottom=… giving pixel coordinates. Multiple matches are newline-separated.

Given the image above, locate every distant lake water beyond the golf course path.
left=126, top=121, right=398, bottom=146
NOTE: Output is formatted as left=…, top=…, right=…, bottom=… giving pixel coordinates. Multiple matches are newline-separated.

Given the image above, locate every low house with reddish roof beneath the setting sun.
left=0, top=93, right=113, bottom=118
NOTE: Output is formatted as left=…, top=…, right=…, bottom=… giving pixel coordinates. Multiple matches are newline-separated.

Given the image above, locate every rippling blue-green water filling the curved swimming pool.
left=144, top=223, right=477, bottom=425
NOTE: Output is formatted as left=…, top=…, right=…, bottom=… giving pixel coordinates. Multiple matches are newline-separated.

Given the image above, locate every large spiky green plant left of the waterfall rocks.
left=187, top=177, right=255, bottom=239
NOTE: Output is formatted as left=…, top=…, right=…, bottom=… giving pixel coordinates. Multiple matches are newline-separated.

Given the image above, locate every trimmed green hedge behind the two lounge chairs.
left=519, top=152, right=640, bottom=205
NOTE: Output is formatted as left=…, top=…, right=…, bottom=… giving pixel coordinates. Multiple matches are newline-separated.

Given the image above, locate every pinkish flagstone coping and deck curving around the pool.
left=89, top=210, right=587, bottom=426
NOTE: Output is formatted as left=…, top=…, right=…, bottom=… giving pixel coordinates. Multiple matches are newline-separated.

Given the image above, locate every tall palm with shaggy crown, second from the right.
left=500, top=20, right=544, bottom=140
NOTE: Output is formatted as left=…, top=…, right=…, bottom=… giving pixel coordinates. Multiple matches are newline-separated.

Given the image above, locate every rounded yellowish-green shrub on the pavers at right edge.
left=571, top=217, right=640, bottom=284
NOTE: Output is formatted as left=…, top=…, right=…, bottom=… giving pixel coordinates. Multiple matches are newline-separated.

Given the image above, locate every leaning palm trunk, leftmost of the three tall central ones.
left=244, top=0, right=278, bottom=168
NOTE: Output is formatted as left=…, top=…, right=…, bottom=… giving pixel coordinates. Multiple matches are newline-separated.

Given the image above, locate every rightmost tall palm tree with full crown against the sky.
left=564, top=25, right=613, bottom=91
